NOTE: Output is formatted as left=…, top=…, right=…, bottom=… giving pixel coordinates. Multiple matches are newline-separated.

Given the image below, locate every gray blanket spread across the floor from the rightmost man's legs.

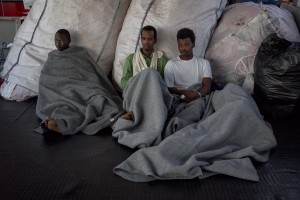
left=114, top=84, right=277, bottom=182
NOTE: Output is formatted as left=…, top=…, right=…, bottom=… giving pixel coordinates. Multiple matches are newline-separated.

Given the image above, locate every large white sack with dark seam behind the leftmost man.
left=1, top=0, right=131, bottom=101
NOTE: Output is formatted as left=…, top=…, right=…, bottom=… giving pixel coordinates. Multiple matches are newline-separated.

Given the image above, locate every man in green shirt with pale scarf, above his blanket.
left=121, top=26, right=168, bottom=89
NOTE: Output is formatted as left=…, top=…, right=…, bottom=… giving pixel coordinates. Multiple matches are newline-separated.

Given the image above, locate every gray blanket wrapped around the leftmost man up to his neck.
left=36, top=47, right=122, bottom=135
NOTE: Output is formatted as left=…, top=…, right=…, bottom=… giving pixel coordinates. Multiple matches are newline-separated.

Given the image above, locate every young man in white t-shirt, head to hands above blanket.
left=164, top=28, right=212, bottom=102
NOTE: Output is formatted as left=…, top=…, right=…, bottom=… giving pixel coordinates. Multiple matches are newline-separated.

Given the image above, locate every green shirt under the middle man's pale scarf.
left=121, top=53, right=168, bottom=89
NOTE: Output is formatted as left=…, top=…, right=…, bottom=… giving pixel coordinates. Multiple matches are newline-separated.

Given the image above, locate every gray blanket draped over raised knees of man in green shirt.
left=112, top=68, right=173, bottom=148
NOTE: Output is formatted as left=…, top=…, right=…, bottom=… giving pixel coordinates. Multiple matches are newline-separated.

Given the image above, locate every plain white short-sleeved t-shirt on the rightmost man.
left=164, top=56, right=212, bottom=89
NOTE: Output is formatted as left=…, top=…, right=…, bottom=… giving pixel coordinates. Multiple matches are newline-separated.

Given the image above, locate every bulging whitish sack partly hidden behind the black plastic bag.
left=205, top=2, right=300, bottom=93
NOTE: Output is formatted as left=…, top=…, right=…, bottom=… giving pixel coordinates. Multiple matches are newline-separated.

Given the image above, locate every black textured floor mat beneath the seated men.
left=0, top=96, right=300, bottom=200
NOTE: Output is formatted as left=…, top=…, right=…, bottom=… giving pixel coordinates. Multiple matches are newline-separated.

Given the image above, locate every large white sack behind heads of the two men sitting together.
left=113, top=0, right=227, bottom=87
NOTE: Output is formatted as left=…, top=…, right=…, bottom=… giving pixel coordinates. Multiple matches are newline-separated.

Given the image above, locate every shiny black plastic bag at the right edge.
left=254, top=33, right=300, bottom=118
